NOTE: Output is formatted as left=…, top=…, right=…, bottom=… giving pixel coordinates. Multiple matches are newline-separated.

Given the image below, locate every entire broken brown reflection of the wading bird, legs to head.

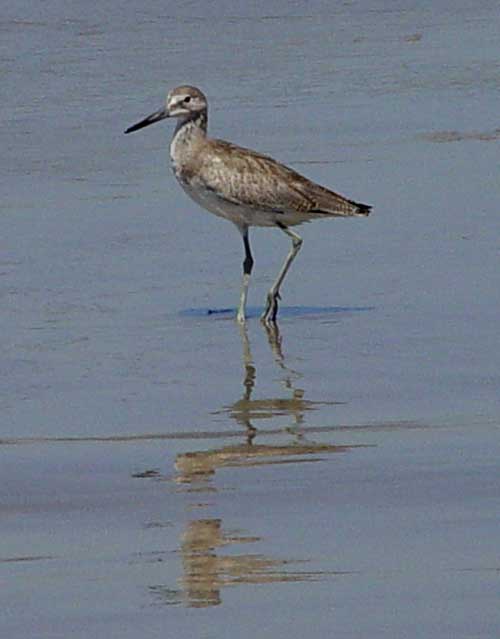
left=151, top=326, right=358, bottom=608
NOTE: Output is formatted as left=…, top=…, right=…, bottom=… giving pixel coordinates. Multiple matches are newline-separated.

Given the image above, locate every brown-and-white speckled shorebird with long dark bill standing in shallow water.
left=125, top=86, right=371, bottom=324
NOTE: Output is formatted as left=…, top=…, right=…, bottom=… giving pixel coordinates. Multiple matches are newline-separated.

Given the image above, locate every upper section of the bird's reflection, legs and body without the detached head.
left=175, top=325, right=349, bottom=490
